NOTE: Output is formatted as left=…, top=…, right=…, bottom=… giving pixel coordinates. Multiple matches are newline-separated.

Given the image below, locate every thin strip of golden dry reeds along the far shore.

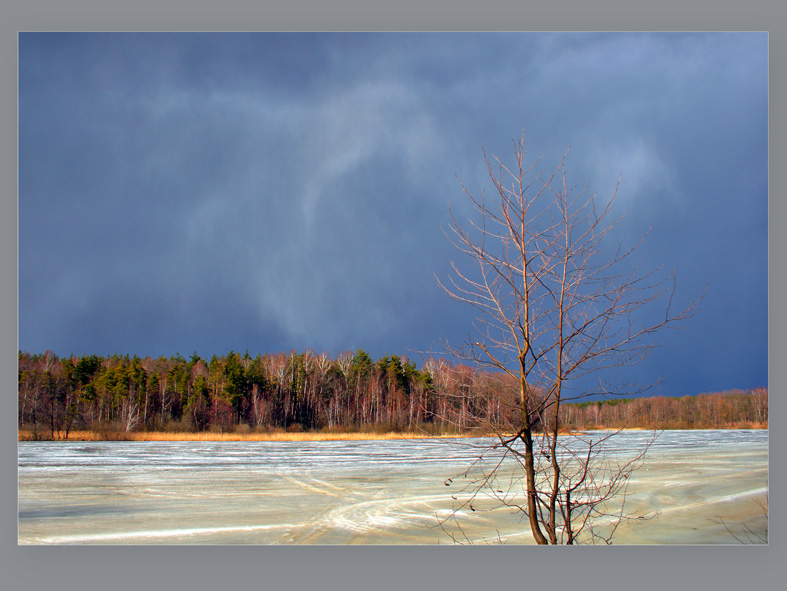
left=17, top=423, right=768, bottom=442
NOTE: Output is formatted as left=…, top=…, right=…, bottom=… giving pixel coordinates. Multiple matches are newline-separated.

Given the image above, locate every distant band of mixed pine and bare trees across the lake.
left=18, top=349, right=768, bottom=439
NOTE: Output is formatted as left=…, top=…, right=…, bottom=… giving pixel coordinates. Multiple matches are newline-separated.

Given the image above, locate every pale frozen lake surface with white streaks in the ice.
left=18, top=430, right=768, bottom=544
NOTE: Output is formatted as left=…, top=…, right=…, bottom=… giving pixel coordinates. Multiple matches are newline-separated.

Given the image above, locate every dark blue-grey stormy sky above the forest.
left=19, top=33, right=768, bottom=395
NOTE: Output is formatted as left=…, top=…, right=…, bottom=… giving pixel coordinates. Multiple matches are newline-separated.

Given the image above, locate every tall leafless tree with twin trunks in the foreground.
left=438, top=137, right=696, bottom=544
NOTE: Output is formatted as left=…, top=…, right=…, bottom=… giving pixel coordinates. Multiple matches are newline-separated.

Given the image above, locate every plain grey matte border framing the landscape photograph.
left=0, top=0, right=787, bottom=590
